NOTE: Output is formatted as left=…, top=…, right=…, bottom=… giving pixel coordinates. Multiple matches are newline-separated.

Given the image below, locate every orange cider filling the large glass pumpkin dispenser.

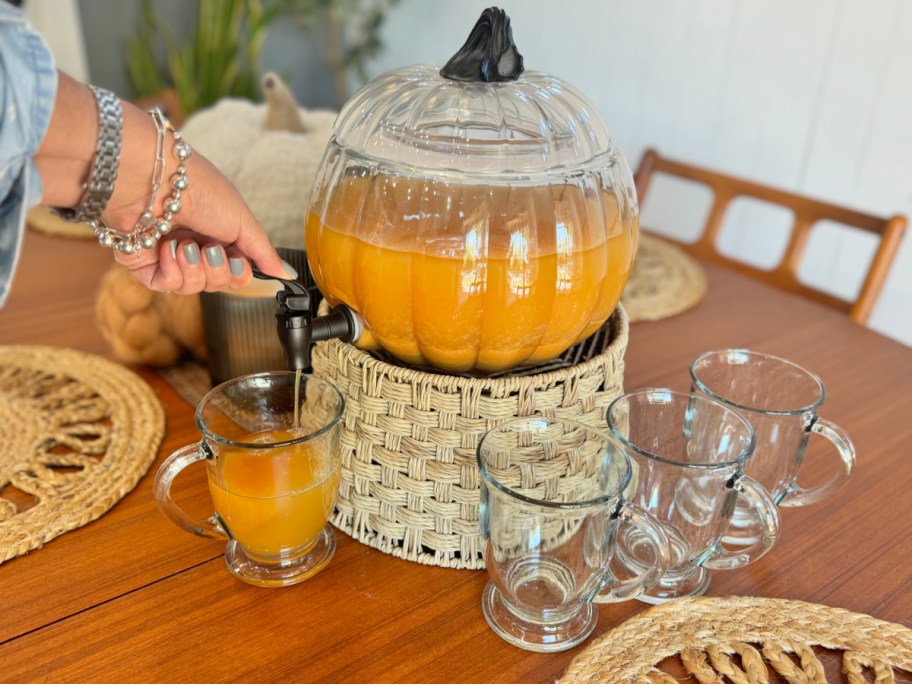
left=305, top=174, right=637, bottom=372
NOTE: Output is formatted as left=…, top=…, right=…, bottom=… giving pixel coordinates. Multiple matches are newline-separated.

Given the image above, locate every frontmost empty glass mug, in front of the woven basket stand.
left=478, top=417, right=668, bottom=652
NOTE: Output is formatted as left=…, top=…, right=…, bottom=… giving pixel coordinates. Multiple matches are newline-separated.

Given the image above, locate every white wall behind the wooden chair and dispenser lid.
left=371, top=0, right=912, bottom=345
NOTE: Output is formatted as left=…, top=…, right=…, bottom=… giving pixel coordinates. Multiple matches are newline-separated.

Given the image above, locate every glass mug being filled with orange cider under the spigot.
left=153, top=371, right=345, bottom=587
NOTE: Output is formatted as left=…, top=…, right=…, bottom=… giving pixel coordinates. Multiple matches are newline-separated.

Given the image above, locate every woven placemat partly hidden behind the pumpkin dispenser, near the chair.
left=621, top=231, right=706, bottom=322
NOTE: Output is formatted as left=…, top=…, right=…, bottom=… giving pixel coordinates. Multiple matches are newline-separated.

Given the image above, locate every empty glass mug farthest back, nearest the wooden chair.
left=690, top=349, right=855, bottom=544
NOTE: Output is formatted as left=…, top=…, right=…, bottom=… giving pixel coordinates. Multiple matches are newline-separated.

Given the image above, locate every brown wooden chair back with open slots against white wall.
left=635, top=149, right=908, bottom=324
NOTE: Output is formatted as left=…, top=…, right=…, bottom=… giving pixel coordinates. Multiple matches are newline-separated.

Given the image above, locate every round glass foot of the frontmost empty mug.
left=481, top=582, right=598, bottom=653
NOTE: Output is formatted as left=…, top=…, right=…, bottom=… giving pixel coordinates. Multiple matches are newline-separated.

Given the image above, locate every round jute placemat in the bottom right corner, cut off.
left=559, top=597, right=912, bottom=684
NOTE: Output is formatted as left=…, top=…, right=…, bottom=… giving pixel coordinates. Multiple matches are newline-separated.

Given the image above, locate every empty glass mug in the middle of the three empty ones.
left=607, top=389, right=779, bottom=603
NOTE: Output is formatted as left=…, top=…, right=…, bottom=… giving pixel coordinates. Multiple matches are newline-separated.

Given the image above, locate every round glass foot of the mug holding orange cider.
left=225, top=523, right=336, bottom=587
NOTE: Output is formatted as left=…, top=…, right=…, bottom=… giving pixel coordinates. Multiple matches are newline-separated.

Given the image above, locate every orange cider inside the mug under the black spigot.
left=209, top=430, right=339, bottom=557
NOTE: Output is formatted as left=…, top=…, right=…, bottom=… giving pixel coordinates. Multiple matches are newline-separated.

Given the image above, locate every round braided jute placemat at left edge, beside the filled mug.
left=0, top=346, right=165, bottom=563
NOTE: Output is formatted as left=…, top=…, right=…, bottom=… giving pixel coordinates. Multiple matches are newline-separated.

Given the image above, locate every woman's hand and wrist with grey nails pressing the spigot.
left=35, top=72, right=288, bottom=294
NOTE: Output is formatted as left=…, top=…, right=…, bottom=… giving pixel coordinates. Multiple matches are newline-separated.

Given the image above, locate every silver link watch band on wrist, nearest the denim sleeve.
left=51, top=86, right=123, bottom=223
